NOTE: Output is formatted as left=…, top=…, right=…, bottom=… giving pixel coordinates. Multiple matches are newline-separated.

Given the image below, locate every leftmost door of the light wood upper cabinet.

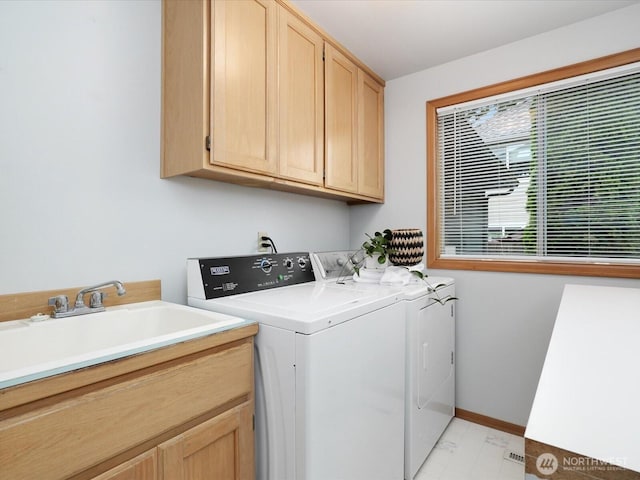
left=211, top=0, right=277, bottom=174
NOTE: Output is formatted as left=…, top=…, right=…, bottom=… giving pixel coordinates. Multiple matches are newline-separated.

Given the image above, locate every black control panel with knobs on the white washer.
left=199, top=252, right=315, bottom=300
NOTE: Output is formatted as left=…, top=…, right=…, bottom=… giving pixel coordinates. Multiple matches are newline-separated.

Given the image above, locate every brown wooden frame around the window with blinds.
left=426, top=48, right=640, bottom=278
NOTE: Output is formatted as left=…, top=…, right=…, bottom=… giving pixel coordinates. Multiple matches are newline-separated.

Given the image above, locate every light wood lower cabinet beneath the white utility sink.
left=0, top=325, right=258, bottom=480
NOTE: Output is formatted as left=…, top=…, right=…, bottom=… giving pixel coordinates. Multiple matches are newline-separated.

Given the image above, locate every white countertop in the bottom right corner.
left=525, top=285, right=640, bottom=472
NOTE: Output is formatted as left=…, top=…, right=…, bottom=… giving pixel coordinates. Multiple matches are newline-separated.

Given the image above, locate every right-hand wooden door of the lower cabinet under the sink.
left=158, top=403, right=255, bottom=480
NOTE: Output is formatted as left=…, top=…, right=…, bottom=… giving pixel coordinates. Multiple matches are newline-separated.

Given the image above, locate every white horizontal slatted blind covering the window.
left=437, top=65, right=640, bottom=263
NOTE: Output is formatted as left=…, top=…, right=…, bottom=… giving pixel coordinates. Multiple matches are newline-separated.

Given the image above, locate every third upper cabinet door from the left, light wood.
left=325, top=44, right=358, bottom=193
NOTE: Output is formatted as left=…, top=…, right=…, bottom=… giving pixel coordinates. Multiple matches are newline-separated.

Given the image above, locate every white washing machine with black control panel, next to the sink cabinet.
left=187, top=252, right=406, bottom=480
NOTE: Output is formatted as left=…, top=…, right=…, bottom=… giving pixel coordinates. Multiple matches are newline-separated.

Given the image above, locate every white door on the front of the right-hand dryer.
left=414, top=292, right=455, bottom=409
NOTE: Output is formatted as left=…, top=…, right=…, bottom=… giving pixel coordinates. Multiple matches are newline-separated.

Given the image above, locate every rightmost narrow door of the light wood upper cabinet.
left=358, top=70, right=384, bottom=199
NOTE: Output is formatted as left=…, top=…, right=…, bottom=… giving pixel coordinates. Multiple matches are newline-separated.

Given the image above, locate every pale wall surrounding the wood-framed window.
left=351, top=5, right=640, bottom=425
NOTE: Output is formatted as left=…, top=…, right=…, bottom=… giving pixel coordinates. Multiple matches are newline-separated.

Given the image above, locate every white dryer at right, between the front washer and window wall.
left=311, top=251, right=455, bottom=480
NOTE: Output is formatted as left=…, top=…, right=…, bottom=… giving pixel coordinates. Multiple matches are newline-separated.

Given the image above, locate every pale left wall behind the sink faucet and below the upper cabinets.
left=0, top=0, right=349, bottom=309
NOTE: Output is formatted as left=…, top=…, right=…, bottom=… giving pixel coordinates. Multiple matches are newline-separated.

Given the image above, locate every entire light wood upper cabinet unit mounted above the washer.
left=161, top=0, right=384, bottom=202
